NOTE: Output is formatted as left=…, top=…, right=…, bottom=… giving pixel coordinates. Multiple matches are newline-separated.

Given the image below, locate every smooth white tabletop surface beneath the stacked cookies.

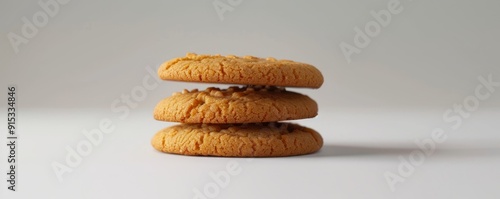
left=2, top=110, right=500, bottom=199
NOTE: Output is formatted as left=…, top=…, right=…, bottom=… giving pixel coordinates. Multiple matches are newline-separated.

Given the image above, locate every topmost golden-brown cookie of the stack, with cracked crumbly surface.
left=158, top=53, right=323, bottom=88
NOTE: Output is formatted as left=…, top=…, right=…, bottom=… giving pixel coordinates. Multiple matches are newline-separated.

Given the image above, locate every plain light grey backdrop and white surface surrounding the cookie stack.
left=0, top=0, right=500, bottom=199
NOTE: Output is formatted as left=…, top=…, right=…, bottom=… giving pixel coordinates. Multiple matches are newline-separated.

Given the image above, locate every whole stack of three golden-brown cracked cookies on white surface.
left=151, top=53, right=323, bottom=157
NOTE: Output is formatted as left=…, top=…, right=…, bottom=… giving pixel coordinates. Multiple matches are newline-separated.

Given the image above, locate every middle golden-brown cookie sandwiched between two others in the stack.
left=154, top=86, right=318, bottom=124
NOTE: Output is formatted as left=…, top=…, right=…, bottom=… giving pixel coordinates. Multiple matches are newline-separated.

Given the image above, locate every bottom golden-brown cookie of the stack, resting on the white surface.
left=151, top=123, right=323, bottom=157
